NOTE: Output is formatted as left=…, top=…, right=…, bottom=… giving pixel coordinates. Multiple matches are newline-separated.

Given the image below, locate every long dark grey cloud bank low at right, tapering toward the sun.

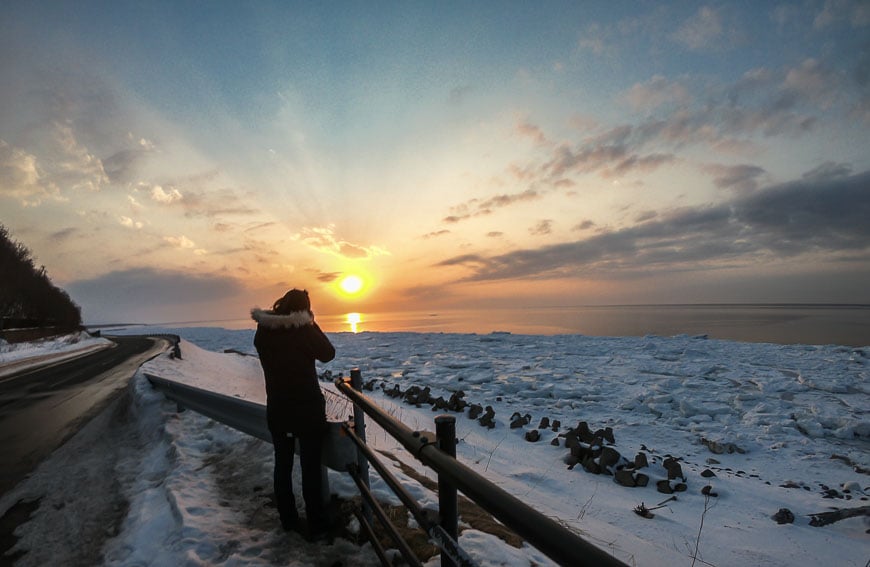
left=438, top=171, right=870, bottom=281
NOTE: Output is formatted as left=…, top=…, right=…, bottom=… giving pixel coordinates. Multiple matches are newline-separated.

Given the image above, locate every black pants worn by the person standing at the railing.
left=270, top=431, right=327, bottom=533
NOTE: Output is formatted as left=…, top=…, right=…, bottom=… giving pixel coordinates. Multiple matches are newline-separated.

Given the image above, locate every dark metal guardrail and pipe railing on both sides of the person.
left=146, top=360, right=625, bottom=567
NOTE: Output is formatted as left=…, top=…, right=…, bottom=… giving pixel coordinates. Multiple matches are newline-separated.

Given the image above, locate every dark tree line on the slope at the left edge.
left=0, top=224, right=82, bottom=329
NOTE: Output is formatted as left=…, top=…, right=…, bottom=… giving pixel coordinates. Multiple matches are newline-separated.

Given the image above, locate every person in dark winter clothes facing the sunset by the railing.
left=251, top=289, right=335, bottom=540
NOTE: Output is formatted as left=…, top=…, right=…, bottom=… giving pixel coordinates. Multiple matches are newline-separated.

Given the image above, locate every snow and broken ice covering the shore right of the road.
left=0, top=328, right=870, bottom=567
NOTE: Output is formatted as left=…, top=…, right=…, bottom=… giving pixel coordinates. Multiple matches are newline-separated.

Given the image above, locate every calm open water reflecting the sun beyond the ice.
left=126, top=304, right=870, bottom=347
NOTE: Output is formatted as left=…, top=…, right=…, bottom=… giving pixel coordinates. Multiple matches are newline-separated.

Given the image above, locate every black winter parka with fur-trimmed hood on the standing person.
left=251, top=309, right=335, bottom=435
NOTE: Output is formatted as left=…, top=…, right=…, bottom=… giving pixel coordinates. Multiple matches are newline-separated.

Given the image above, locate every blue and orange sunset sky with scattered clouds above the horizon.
left=0, top=0, right=870, bottom=323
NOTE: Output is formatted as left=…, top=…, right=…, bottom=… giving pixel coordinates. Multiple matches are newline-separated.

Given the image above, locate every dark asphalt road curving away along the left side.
left=0, top=336, right=167, bottom=495
